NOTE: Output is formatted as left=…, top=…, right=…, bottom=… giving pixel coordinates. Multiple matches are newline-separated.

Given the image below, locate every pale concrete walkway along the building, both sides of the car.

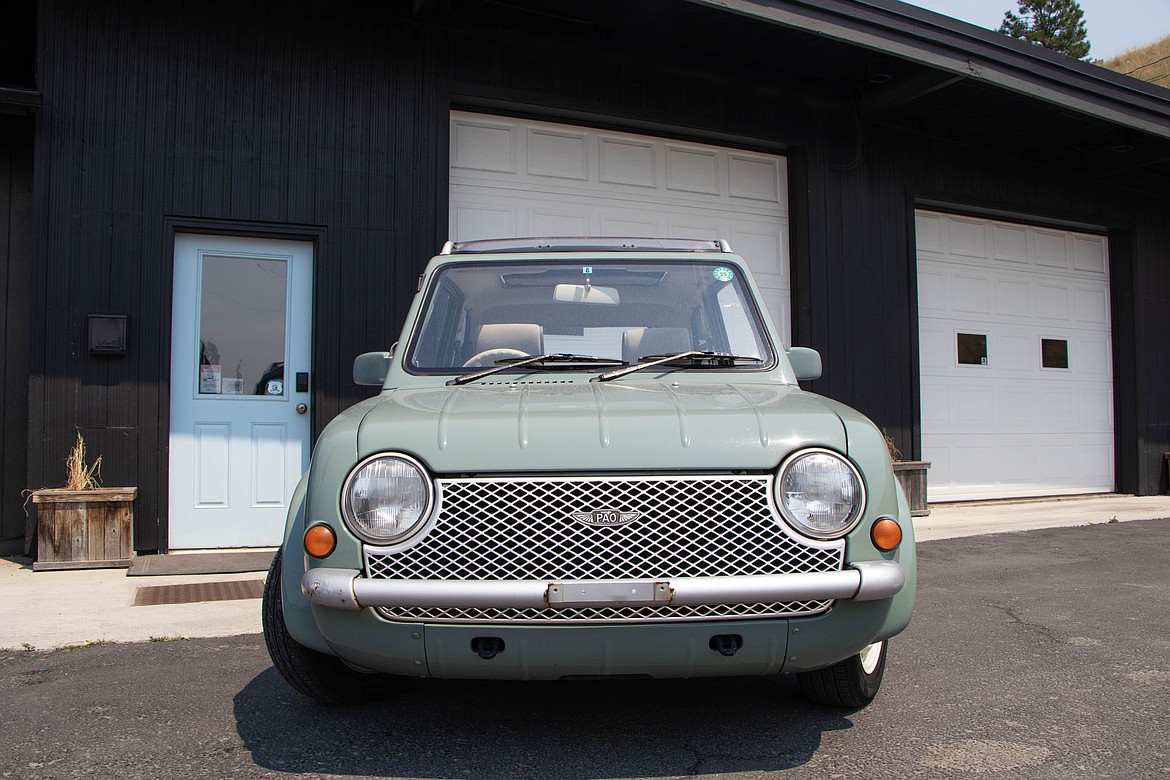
left=0, top=496, right=1170, bottom=650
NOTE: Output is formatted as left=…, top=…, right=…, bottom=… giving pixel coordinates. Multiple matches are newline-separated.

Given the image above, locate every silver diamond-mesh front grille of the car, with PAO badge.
left=366, top=476, right=845, bottom=623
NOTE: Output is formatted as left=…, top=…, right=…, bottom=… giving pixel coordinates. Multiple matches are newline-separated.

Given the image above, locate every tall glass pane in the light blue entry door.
left=199, top=255, right=288, bottom=398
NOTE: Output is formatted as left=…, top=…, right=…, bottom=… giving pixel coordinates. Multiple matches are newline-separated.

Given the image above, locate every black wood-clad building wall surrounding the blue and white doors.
left=28, top=0, right=1170, bottom=550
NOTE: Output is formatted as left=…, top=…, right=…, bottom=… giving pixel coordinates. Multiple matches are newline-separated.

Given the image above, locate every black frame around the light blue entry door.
left=160, top=216, right=328, bottom=553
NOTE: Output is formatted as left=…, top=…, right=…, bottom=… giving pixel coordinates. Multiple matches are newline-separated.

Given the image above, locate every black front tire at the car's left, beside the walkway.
left=261, top=548, right=397, bottom=706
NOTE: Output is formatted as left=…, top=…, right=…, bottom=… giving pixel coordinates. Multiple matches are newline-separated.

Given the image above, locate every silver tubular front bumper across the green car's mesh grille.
left=301, top=560, right=906, bottom=612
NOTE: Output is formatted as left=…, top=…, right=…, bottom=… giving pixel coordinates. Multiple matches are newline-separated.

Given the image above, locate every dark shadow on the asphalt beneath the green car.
left=234, top=669, right=853, bottom=780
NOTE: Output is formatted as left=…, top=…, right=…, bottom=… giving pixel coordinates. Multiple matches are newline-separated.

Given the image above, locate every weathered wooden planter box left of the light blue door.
left=33, top=488, right=138, bottom=571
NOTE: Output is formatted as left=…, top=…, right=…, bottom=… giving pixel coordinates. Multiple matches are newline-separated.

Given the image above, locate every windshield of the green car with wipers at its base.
left=406, top=257, right=773, bottom=373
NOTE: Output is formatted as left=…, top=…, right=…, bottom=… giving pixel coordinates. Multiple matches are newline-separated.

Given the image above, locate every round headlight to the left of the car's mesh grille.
left=342, top=455, right=432, bottom=544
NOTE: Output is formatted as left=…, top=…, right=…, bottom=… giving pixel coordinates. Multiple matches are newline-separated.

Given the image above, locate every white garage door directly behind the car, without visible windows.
left=449, top=112, right=791, bottom=341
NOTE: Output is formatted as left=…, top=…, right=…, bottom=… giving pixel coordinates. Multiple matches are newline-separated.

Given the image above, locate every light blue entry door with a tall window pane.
left=170, top=234, right=312, bottom=550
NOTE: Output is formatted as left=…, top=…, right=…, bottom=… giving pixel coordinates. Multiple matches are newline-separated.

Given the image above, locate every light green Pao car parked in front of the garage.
left=263, top=239, right=915, bottom=707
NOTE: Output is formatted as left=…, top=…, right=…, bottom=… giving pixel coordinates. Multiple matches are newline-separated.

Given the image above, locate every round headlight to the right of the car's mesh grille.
left=776, top=449, right=866, bottom=539
